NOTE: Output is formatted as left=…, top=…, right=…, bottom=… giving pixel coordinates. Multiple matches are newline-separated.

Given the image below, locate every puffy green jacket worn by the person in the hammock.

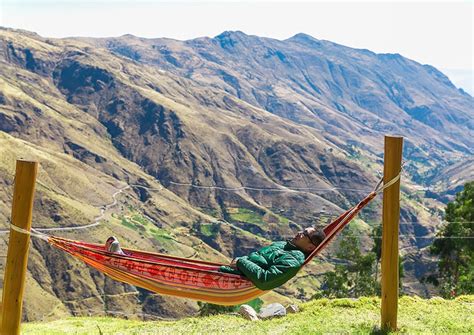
left=220, top=241, right=305, bottom=290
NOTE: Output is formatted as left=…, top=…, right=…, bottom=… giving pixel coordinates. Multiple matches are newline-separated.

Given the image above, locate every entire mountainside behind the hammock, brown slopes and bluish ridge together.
left=0, top=28, right=474, bottom=320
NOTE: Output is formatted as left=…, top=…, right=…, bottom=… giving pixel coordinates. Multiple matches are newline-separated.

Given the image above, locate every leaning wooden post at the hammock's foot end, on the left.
left=0, top=160, right=38, bottom=335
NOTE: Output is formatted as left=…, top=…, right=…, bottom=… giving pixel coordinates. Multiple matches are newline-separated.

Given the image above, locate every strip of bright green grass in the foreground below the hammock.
left=22, top=296, right=474, bottom=335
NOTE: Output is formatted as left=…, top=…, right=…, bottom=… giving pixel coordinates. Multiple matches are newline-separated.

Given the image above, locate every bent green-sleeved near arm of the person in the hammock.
left=237, top=253, right=302, bottom=290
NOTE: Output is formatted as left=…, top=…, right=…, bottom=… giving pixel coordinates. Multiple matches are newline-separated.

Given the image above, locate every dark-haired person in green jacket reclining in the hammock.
left=219, top=227, right=326, bottom=290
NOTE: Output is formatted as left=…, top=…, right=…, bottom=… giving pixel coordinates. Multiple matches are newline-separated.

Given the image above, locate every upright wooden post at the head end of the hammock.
left=381, top=136, right=403, bottom=331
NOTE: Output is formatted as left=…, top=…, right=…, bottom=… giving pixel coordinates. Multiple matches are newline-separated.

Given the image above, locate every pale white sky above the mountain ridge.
left=0, top=0, right=474, bottom=95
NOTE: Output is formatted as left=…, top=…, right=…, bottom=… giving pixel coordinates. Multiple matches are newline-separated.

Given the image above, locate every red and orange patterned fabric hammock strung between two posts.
left=47, top=192, right=378, bottom=305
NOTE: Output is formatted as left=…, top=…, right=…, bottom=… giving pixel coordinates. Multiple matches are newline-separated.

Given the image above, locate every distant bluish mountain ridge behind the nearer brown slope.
left=79, top=31, right=474, bottom=179
